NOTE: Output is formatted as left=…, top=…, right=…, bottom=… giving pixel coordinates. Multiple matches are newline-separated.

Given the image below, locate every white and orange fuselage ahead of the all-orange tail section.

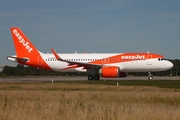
left=39, top=53, right=173, bottom=72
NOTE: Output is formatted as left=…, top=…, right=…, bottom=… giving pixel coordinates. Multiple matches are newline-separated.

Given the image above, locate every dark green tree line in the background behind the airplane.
left=0, top=59, right=180, bottom=76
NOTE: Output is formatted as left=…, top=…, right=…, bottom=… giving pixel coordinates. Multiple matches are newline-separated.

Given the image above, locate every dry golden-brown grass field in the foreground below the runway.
left=0, top=81, right=180, bottom=120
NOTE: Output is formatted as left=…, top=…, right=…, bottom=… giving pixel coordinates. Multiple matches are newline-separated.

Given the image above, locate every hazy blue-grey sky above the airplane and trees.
left=0, top=0, right=180, bottom=64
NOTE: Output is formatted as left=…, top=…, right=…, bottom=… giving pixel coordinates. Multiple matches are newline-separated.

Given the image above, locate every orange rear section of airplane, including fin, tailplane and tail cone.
left=8, top=28, right=52, bottom=70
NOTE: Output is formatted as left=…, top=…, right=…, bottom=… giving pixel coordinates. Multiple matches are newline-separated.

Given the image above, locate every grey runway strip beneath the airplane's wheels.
left=0, top=76, right=180, bottom=82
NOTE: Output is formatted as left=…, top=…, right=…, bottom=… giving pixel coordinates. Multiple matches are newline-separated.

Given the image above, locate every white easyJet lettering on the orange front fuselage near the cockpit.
left=121, top=55, right=145, bottom=60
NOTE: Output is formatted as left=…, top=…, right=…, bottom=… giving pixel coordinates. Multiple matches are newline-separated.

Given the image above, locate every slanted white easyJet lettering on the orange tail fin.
left=13, top=29, right=33, bottom=53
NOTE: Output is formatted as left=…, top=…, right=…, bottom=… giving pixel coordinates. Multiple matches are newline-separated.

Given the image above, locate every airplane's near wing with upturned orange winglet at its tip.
left=51, top=49, right=102, bottom=69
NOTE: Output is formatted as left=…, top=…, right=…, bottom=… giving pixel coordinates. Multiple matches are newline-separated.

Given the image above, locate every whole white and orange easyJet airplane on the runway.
left=7, top=27, right=173, bottom=80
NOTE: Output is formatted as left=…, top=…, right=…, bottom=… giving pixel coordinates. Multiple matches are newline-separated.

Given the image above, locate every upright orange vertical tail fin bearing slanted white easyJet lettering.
left=11, top=28, right=39, bottom=58
